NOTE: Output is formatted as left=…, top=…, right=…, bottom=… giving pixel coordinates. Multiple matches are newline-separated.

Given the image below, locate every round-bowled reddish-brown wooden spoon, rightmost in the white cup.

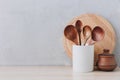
left=88, top=26, right=105, bottom=45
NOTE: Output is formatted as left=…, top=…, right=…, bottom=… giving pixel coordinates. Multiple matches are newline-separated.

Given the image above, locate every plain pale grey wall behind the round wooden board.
left=0, top=0, right=120, bottom=65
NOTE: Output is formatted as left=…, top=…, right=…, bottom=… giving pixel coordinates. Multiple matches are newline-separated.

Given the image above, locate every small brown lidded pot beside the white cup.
left=97, top=49, right=117, bottom=71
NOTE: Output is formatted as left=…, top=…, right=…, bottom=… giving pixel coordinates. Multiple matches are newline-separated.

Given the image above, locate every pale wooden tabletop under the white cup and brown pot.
left=0, top=66, right=120, bottom=80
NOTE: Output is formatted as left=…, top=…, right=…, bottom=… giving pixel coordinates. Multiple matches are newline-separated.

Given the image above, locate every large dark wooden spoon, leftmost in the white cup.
left=64, top=25, right=78, bottom=45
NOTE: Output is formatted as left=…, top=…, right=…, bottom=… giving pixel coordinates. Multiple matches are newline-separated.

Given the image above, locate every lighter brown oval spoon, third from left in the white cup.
left=83, top=25, right=92, bottom=45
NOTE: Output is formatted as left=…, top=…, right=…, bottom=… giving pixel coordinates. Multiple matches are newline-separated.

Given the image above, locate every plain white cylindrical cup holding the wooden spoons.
left=72, top=45, right=94, bottom=72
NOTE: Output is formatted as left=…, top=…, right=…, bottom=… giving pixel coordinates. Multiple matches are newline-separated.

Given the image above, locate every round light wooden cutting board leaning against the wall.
left=63, top=14, right=115, bottom=64
